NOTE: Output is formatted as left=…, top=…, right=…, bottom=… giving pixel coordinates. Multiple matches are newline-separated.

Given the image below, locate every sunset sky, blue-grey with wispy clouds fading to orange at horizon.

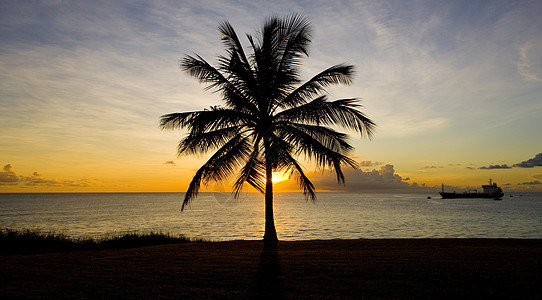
left=0, top=0, right=542, bottom=193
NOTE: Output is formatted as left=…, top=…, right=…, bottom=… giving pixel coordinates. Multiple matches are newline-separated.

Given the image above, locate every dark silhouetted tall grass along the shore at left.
left=0, top=228, right=200, bottom=255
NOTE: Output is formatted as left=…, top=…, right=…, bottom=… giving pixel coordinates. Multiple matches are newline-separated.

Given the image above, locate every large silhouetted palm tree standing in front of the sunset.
left=160, top=15, right=375, bottom=242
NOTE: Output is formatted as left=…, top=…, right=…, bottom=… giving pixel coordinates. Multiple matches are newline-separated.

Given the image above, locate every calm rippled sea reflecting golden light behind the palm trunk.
left=0, top=193, right=542, bottom=240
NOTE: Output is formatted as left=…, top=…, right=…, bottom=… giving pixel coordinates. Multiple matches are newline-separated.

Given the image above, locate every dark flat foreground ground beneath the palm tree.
left=0, top=239, right=542, bottom=299
